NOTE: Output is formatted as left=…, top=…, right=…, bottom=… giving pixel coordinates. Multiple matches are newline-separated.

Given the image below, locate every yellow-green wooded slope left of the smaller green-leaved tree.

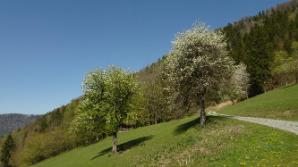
left=2, top=99, right=79, bottom=166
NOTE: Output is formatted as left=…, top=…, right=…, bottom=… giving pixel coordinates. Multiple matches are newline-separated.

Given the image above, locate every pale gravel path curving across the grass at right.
left=209, top=112, right=298, bottom=135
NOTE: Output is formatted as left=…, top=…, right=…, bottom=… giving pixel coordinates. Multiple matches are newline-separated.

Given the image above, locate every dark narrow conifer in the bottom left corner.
left=0, top=135, right=15, bottom=167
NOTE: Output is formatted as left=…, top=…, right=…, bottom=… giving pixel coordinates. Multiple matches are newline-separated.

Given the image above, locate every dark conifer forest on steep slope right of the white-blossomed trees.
left=222, top=0, right=298, bottom=96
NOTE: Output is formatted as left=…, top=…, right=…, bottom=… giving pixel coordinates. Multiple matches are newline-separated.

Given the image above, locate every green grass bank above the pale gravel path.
left=218, top=85, right=298, bottom=120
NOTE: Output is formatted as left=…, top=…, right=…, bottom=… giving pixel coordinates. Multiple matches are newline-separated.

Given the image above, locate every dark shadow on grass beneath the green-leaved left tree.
left=91, top=135, right=153, bottom=160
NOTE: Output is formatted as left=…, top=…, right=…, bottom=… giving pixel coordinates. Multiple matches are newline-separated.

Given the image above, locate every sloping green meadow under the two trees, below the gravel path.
left=30, top=116, right=298, bottom=167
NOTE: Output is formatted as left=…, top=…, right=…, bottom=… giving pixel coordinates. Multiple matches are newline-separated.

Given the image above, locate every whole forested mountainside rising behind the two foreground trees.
left=0, top=1, right=298, bottom=166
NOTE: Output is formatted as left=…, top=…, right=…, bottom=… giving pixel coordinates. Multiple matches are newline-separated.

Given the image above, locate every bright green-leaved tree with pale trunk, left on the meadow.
left=72, top=67, right=137, bottom=152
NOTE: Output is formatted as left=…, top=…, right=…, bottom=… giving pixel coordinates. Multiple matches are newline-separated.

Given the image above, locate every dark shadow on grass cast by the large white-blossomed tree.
left=174, top=115, right=226, bottom=135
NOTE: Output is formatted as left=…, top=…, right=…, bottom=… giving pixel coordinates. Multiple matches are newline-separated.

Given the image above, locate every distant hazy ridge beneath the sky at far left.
left=0, top=114, right=39, bottom=137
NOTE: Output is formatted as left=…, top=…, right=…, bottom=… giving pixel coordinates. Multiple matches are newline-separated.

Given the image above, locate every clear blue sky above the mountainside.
left=0, top=0, right=285, bottom=114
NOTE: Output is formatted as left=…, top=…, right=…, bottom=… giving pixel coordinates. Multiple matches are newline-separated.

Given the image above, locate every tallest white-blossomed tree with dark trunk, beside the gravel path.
left=166, top=23, right=233, bottom=126
